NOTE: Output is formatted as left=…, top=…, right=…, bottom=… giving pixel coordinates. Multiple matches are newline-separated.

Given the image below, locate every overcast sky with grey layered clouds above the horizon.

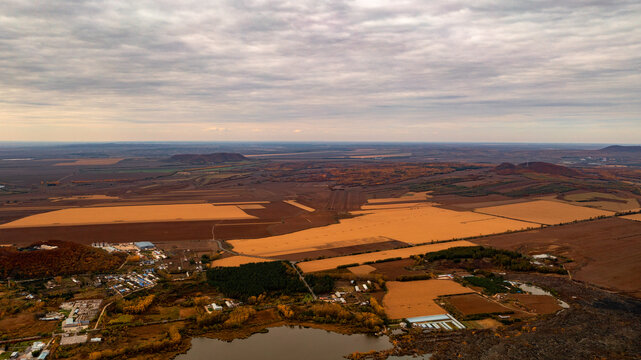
left=0, top=0, right=641, bottom=143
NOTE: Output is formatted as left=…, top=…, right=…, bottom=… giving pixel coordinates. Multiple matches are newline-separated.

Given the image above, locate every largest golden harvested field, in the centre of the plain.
left=229, top=205, right=531, bottom=256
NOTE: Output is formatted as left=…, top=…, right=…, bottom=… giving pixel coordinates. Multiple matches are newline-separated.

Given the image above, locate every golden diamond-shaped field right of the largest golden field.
left=475, top=200, right=614, bottom=225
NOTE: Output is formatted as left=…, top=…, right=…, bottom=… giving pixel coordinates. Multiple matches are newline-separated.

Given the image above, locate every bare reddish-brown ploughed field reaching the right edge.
left=475, top=217, right=641, bottom=297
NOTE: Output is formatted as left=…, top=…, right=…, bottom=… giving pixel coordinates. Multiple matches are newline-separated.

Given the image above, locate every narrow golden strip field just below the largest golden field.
left=298, top=240, right=476, bottom=273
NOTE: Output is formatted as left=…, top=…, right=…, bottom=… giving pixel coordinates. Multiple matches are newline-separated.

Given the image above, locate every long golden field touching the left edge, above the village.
left=0, top=204, right=255, bottom=228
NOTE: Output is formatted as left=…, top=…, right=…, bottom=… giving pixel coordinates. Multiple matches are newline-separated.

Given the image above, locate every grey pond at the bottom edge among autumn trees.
left=175, top=326, right=392, bottom=360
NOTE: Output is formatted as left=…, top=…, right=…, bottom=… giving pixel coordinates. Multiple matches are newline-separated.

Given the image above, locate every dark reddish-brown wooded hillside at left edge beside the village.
left=0, top=240, right=126, bottom=279
